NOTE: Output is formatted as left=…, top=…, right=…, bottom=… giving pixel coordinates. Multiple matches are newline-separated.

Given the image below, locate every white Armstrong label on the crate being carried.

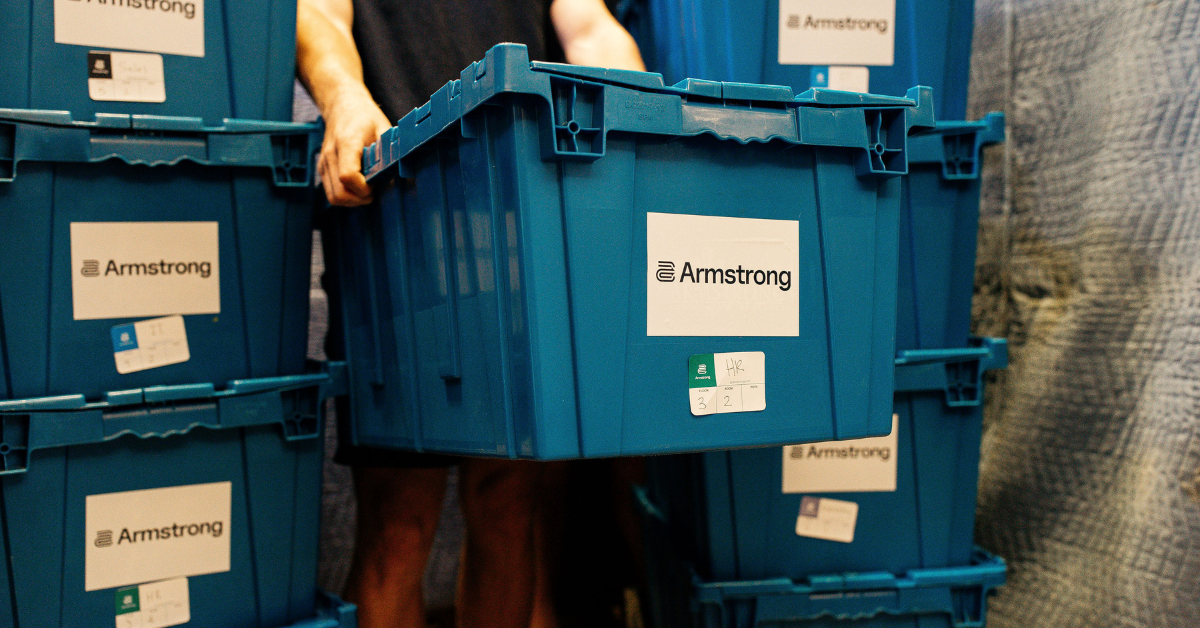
left=646, top=213, right=800, bottom=336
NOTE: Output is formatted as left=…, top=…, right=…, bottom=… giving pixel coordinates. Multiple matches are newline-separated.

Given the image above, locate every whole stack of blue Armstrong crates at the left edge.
left=0, top=0, right=355, bottom=628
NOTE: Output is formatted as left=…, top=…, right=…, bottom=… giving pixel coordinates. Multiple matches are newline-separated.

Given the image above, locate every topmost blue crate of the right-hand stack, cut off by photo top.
left=630, top=0, right=974, bottom=120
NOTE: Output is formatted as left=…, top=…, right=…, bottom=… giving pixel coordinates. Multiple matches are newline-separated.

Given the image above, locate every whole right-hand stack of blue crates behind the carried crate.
left=630, top=0, right=1007, bottom=628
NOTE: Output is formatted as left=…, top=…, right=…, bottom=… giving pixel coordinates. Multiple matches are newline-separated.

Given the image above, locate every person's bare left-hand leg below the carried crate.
left=346, top=467, right=446, bottom=628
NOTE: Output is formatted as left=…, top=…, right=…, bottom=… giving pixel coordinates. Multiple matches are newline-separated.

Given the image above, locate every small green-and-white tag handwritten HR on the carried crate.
left=688, top=351, right=767, bottom=417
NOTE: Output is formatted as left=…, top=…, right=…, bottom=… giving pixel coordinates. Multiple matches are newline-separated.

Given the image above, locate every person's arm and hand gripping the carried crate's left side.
left=296, top=0, right=391, bottom=205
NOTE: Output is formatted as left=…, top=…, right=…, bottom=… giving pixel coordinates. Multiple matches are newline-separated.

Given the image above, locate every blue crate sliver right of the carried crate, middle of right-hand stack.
left=896, top=113, right=1004, bottom=349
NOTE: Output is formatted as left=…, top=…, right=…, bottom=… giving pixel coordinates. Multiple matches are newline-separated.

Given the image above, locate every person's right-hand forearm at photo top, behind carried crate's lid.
left=550, top=0, right=646, bottom=71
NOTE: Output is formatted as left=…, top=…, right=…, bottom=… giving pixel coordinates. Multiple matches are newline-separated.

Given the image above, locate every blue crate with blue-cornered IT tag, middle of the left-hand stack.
left=0, top=109, right=320, bottom=399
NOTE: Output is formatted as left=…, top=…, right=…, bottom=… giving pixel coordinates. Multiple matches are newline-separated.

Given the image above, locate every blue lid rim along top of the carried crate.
left=362, top=43, right=934, bottom=179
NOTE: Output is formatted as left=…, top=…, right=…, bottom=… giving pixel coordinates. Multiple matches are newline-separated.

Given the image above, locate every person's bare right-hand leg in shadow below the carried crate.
left=458, top=459, right=541, bottom=628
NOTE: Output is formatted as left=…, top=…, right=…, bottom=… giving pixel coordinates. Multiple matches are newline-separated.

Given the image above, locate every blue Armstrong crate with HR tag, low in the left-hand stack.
left=0, top=373, right=338, bottom=628
